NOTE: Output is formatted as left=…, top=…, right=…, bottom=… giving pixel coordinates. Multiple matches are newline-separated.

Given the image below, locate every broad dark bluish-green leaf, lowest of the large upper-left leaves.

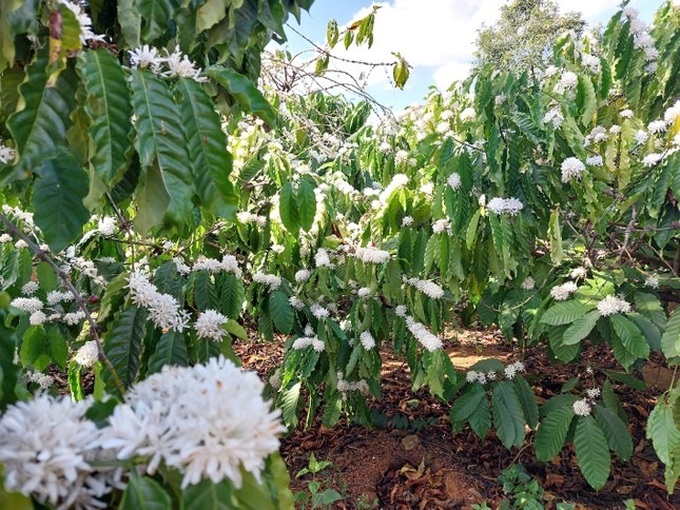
left=32, top=152, right=90, bottom=253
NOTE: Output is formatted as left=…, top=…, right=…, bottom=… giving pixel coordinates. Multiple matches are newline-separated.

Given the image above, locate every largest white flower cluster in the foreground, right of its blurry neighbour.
left=101, top=356, right=285, bottom=488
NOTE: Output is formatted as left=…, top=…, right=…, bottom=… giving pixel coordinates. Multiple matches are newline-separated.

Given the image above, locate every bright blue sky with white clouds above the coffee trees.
left=274, top=0, right=664, bottom=110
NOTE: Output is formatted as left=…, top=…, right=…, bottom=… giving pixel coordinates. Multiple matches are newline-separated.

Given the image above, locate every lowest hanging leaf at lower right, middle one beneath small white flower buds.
left=574, top=416, right=611, bottom=491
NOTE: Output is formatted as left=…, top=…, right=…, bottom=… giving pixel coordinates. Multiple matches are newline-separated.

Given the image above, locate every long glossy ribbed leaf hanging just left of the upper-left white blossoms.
left=77, top=48, right=132, bottom=188
